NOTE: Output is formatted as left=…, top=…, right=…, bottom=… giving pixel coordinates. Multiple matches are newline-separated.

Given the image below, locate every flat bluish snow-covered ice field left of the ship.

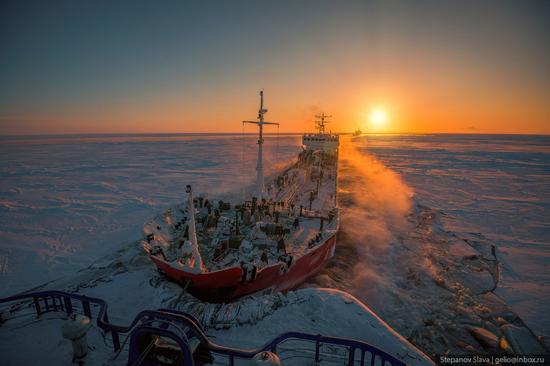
left=0, top=134, right=300, bottom=296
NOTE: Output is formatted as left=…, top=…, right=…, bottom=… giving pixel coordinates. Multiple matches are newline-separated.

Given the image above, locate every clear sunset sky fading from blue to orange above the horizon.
left=0, top=0, right=550, bottom=135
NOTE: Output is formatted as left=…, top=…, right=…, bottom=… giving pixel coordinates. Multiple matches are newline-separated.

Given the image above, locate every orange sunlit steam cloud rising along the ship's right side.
left=310, top=139, right=413, bottom=296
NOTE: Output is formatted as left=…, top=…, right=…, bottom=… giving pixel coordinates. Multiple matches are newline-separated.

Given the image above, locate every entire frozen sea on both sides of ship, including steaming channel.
left=0, top=135, right=550, bottom=354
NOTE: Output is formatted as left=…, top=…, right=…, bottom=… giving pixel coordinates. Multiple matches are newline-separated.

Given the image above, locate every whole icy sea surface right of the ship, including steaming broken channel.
left=312, top=136, right=550, bottom=355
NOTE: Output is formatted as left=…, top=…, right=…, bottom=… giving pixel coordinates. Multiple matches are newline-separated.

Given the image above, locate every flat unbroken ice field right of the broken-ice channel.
left=355, top=134, right=550, bottom=335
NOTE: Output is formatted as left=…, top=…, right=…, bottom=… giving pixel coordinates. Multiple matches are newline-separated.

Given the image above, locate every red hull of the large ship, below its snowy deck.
left=150, top=234, right=336, bottom=303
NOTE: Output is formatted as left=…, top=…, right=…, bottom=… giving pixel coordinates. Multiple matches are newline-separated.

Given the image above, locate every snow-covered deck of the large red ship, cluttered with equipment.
left=144, top=153, right=338, bottom=271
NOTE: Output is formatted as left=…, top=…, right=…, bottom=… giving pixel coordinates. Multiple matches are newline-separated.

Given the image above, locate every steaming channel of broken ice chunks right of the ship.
left=312, top=140, right=544, bottom=356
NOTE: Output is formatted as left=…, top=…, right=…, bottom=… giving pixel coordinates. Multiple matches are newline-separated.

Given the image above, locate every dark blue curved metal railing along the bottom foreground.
left=0, top=291, right=405, bottom=366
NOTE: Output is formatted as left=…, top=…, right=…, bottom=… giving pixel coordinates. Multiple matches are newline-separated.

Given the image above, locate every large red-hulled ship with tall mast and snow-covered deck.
left=141, top=91, right=339, bottom=302
